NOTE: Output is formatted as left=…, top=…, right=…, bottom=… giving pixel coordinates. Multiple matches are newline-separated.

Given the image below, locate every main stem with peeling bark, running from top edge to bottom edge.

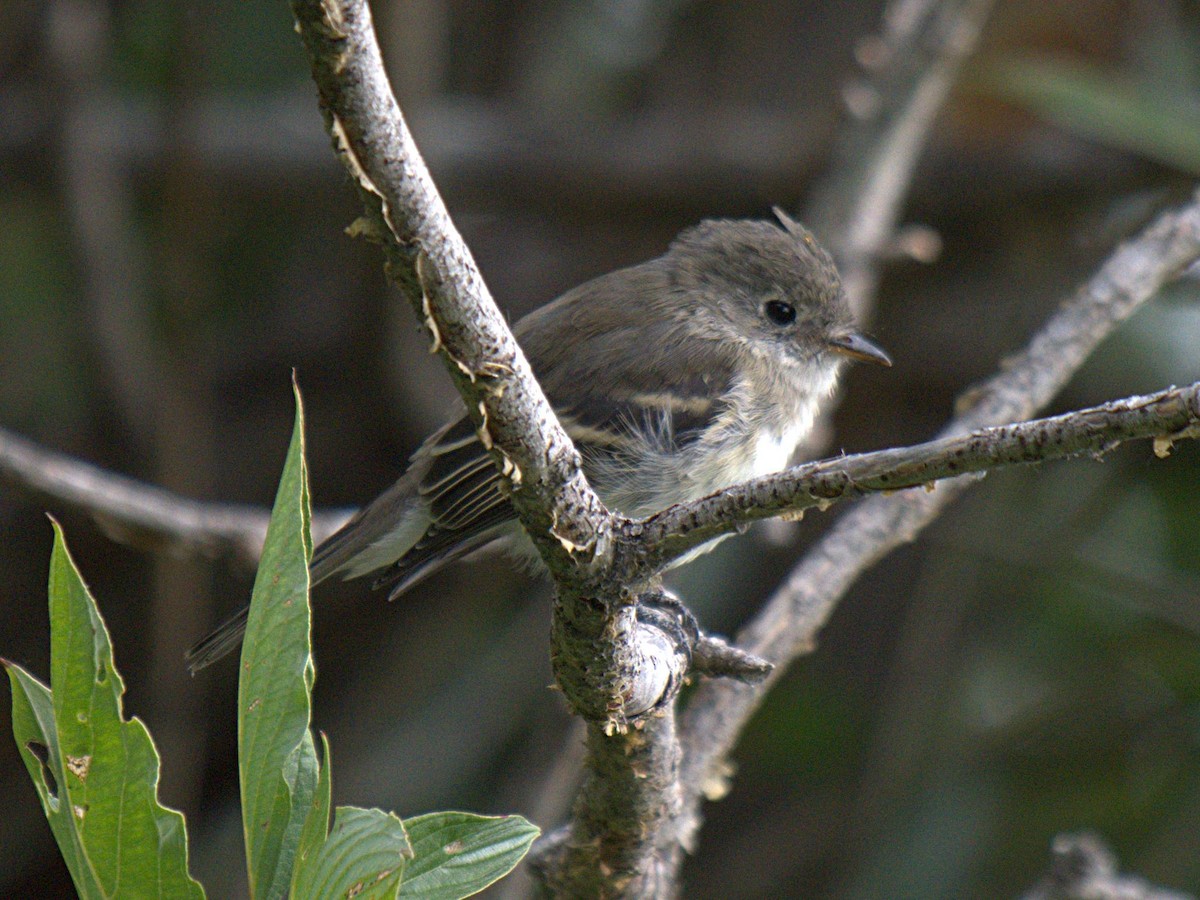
left=293, top=0, right=679, bottom=896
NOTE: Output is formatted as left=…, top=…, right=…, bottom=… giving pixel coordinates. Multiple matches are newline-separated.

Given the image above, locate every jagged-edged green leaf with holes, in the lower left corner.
left=7, top=523, right=204, bottom=898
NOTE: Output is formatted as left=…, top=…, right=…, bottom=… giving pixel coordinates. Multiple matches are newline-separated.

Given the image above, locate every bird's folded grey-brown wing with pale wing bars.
left=376, top=260, right=736, bottom=596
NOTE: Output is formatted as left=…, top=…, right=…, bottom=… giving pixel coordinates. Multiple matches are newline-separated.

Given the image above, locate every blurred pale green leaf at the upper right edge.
left=986, top=59, right=1200, bottom=174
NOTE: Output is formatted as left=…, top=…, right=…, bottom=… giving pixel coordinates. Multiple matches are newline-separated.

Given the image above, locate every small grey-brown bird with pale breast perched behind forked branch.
left=187, top=209, right=892, bottom=672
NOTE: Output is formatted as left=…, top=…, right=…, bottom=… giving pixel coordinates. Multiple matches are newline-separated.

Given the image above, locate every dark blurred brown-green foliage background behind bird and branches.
left=0, top=0, right=1200, bottom=898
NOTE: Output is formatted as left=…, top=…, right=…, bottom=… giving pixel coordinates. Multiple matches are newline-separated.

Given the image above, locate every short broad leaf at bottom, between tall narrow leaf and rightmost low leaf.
left=292, top=806, right=413, bottom=900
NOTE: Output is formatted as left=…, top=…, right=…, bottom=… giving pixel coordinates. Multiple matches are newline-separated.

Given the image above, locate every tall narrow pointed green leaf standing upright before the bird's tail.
left=238, top=389, right=318, bottom=899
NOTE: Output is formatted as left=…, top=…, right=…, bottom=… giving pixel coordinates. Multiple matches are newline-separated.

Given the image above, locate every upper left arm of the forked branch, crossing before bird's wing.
left=292, top=0, right=608, bottom=592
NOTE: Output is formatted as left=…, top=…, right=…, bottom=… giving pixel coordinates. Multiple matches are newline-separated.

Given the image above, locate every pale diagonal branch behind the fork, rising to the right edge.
left=680, top=193, right=1200, bottom=859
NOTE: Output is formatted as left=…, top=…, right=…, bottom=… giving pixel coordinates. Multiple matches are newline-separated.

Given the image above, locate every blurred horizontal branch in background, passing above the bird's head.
left=0, top=85, right=1135, bottom=218
